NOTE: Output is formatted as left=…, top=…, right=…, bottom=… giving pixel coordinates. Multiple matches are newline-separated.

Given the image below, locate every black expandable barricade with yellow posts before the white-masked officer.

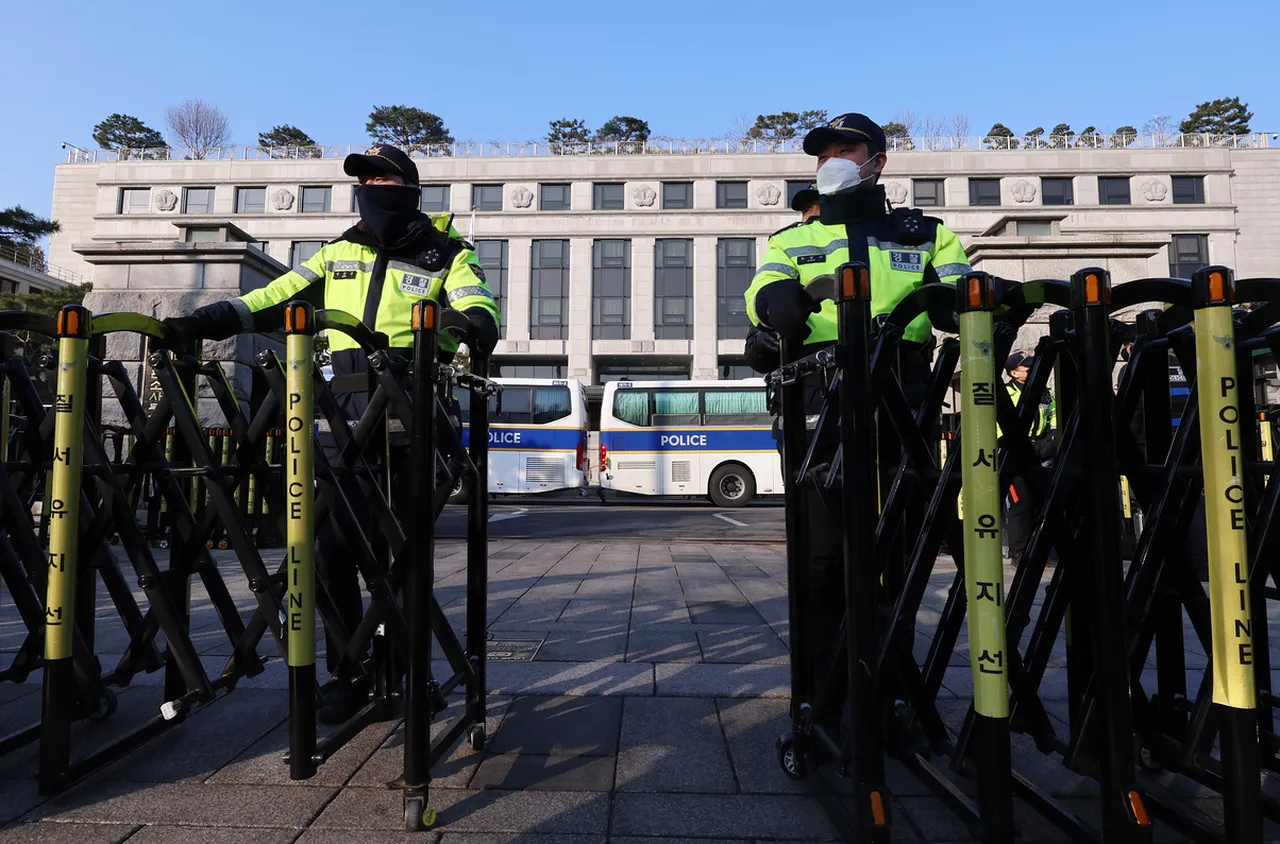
left=768, top=264, right=1280, bottom=844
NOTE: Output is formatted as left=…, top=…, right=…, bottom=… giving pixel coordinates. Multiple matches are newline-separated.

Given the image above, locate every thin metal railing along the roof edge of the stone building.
left=65, top=132, right=1280, bottom=164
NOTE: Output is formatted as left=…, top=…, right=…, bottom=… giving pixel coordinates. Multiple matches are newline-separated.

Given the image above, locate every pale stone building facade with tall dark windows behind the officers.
left=50, top=136, right=1280, bottom=384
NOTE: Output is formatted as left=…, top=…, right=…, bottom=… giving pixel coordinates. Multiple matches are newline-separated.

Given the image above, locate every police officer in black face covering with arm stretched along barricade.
left=165, top=143, right=499, bottom=724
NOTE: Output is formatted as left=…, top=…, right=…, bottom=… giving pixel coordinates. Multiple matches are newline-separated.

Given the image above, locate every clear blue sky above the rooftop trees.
left=0, top=0, right=1280, bottom=230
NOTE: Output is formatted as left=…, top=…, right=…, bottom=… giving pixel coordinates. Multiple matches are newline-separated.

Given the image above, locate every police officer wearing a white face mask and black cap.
left=746, top=113, right=970, bottom=706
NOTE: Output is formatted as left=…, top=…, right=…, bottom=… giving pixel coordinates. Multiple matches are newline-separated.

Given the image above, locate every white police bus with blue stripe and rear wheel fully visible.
left=600, top=378, right=782, bottom=507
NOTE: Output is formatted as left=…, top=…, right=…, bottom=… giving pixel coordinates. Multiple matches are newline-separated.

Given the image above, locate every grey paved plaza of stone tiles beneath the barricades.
left=0, top=539, right=1280, bottom=844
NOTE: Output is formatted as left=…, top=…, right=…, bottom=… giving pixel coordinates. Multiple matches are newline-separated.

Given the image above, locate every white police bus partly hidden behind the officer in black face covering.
left=449, top=378, right=589, bottom=503
